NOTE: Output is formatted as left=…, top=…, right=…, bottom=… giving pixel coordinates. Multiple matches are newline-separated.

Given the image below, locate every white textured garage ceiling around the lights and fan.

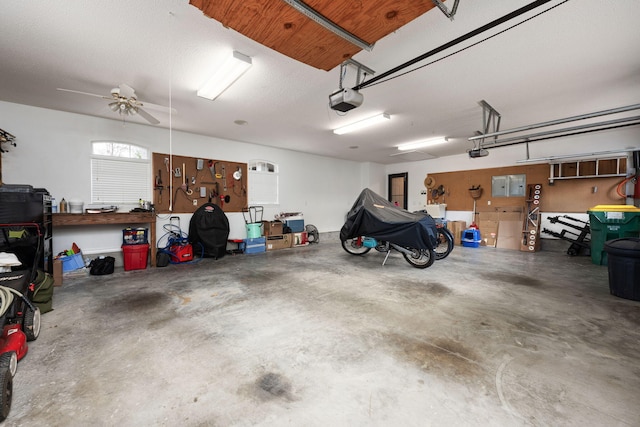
left=0, top=0, right=640, bottom=164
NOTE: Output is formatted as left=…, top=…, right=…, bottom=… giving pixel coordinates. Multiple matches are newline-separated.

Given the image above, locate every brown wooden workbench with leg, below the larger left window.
left=52, top=212, right=156, bottom=267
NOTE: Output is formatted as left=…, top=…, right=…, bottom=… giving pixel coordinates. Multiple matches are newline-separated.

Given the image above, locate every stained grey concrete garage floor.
left=5, top=233, right=640, bottom=426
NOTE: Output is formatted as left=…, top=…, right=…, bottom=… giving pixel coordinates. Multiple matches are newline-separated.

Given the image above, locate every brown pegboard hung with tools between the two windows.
left=153, top=153, right=247, bottom=213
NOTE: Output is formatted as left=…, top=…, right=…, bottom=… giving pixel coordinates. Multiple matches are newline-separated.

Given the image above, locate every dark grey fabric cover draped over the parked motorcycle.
left=340, top=188, right=438, bottom=249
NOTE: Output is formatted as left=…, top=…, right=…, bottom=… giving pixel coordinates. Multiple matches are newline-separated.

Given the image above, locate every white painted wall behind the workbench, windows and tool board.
left=0, top=102, right=368, bottom=254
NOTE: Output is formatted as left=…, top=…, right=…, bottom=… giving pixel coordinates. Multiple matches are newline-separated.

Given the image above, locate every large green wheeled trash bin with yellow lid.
left=587, top=205, right=640, bottom=265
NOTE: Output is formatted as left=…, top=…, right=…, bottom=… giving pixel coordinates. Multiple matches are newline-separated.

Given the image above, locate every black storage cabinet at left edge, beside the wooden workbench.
left=0, top=184, right=53, bottom=273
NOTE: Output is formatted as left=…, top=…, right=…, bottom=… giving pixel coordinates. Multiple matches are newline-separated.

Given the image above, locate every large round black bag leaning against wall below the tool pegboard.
left=189, top=203, right=229, bottom=259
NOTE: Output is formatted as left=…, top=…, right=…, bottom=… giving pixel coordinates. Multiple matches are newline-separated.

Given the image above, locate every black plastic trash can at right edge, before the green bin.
left=604, top=237, right=640, bottom=301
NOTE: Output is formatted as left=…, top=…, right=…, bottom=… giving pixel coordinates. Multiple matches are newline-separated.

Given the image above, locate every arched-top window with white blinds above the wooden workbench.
left=91, top=141, right=152, bottom=205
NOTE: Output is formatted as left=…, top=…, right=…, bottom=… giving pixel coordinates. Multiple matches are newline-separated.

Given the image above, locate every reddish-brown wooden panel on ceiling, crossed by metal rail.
left=189, top=0, right=434, bottom=71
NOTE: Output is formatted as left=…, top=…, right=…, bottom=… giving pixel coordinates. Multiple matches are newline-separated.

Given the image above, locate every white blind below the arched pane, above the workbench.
left=91, top=157, right=151, bottom=204
